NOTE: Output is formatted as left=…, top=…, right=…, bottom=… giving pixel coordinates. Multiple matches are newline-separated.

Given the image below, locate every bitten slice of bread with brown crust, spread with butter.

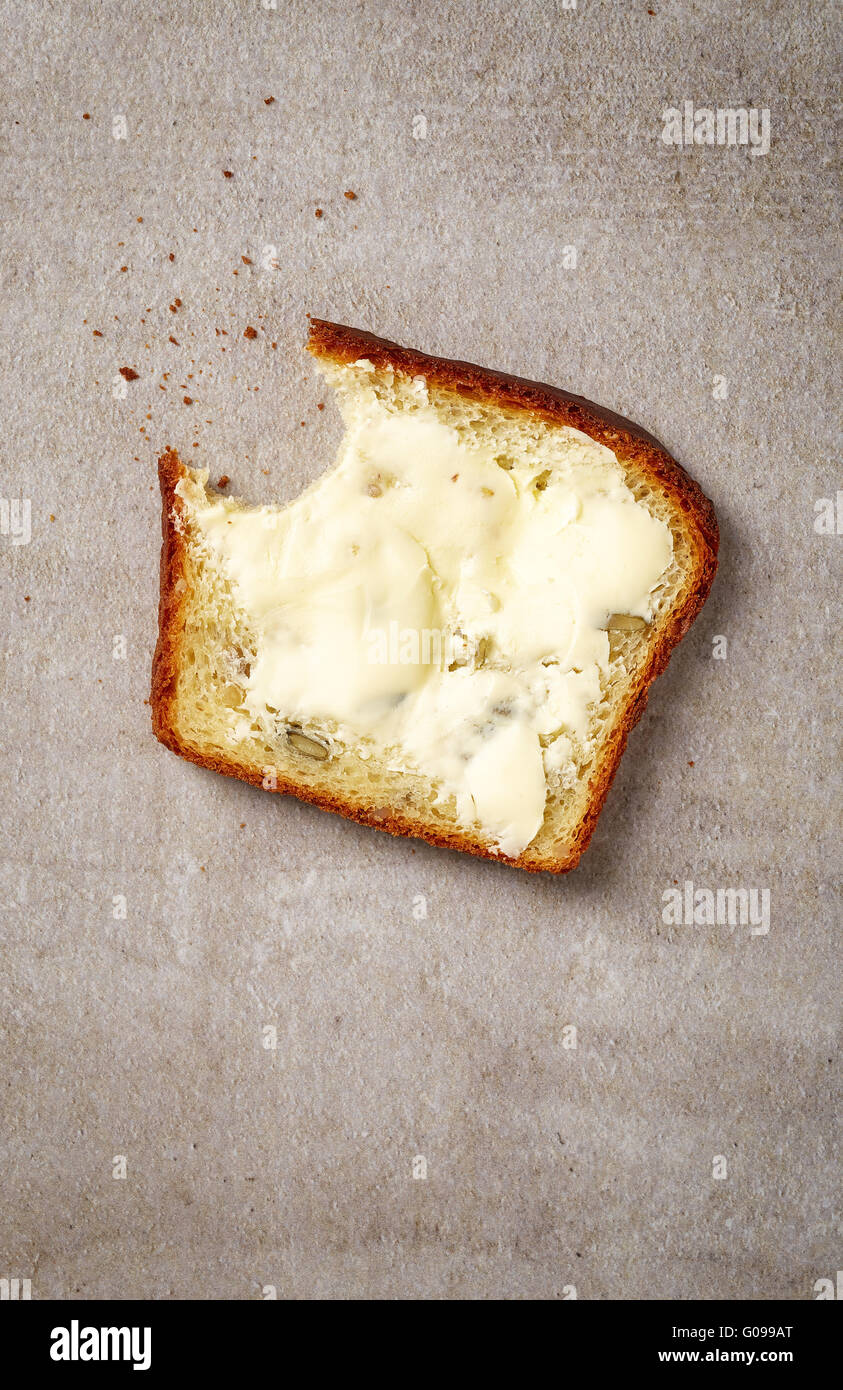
left=152, top=320, right=718, bottom=873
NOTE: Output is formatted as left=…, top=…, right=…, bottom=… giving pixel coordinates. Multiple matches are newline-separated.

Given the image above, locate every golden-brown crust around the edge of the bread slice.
left=150, top=318, right=718, bottom=873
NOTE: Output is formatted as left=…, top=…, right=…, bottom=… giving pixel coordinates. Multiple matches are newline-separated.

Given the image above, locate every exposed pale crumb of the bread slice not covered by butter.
left=162, top=361, right=694, bottom=866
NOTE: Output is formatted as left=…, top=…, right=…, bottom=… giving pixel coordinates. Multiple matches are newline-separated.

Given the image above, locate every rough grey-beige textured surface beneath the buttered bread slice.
left=0, top=0, right=842, bottom=1300
